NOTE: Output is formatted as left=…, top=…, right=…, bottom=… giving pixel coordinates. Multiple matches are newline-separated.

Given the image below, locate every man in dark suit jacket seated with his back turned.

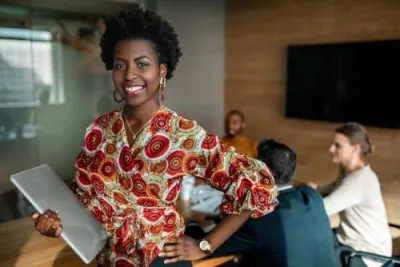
left=191, top=140, right=338, bottom=267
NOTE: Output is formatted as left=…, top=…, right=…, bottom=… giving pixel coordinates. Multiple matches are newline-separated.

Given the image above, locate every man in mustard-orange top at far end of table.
left=222, top=110, right=257, bottom=158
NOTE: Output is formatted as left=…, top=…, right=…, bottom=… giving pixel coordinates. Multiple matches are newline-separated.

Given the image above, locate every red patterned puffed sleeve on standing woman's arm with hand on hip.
left=187, top=126, right=278, bottom=218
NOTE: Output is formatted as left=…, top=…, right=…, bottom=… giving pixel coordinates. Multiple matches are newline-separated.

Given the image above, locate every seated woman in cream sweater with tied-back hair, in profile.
left=310, top=123, right=392, bottom=266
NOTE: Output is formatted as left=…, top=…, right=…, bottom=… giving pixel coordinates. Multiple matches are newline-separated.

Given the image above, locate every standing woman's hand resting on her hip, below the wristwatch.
left=159, top=236, right=206, bottom=264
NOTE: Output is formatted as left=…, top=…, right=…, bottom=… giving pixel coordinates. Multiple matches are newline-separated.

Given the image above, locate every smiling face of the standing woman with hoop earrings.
left=112, top=40, right=167, bottom=106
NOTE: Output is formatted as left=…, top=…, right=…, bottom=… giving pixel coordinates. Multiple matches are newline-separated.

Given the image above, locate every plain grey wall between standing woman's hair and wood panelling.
left=154, top=0, right=225, bottom=135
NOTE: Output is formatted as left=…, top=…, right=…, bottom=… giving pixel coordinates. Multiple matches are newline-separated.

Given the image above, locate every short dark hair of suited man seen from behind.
left=257, top=139, right=296, bottom=185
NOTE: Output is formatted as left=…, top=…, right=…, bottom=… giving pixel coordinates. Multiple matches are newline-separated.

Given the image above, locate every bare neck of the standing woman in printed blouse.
left=124, top=101, right=160, bottom=125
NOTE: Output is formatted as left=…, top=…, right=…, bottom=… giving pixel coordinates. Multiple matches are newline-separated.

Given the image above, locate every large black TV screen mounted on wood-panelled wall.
left=286, top=40, right=400, bottom=129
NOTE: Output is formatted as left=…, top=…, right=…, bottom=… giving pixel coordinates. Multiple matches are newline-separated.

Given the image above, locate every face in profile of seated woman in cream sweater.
left=329, top=133, right=358, bottom=165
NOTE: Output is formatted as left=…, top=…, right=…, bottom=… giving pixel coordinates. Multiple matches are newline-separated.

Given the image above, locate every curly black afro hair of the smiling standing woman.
left=100, top=5, right=182, bottom=79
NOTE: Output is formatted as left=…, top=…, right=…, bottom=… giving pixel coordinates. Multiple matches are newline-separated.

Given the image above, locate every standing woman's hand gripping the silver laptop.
left=32, top=210, right=62, bottom=237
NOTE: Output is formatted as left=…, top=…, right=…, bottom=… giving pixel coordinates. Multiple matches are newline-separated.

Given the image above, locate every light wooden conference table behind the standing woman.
left=0, top=201, right=234, bottom=267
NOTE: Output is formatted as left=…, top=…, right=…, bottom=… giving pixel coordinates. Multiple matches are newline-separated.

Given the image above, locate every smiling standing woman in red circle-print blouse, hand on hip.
left=32, top=6, right=278, bottom=267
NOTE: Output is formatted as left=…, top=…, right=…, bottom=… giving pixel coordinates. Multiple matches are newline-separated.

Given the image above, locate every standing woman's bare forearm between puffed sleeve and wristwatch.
left=207, top=210, right=251, bottom=252
